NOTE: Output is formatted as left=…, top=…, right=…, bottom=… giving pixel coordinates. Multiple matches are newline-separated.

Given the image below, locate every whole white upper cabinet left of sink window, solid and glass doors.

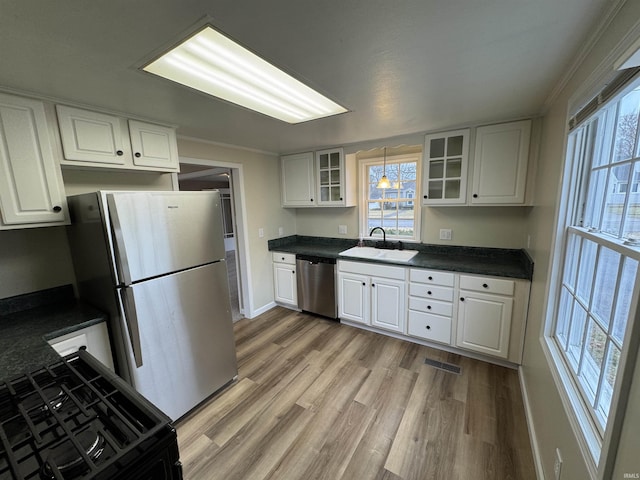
left=280, top=148, right=357, bottom=207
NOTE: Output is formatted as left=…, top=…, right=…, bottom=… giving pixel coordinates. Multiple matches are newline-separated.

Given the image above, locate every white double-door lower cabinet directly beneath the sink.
left=338, top=260, right=407, bottom=333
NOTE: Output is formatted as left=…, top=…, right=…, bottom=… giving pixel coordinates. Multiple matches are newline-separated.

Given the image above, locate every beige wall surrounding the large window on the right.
left=521, top=1, right=640, bottom=480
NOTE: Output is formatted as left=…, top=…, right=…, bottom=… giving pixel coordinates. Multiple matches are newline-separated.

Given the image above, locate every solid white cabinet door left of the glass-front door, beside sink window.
left=280, top=152, right=316, bottom=207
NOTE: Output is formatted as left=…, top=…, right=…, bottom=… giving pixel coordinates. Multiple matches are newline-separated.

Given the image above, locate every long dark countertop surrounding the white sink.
left=268, top=235, right=533, bottom=280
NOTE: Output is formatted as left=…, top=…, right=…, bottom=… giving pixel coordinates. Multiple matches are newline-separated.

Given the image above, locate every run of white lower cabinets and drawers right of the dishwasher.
left=338, top=260, right=530, bottom=364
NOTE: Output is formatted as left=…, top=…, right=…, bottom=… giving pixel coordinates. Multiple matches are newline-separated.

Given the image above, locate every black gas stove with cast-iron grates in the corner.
left=0, top=351, right=182, bottom=480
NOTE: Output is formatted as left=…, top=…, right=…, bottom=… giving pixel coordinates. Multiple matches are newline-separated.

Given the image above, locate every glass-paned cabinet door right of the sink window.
left=422, top=129, right=469, bottom=205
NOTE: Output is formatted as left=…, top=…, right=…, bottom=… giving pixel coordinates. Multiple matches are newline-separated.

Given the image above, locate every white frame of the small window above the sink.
left=358, top=152, right=422, bottom=243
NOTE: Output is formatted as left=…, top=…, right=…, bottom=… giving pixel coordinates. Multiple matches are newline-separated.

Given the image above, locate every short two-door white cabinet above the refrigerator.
left=56, top=105, right=179, bottom=172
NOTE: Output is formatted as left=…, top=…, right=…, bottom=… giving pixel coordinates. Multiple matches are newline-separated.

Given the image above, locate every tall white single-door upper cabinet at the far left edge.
left=0, top=94, right=69, bottom=229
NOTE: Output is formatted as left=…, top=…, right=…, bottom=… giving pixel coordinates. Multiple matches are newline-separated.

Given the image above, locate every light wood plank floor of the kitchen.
left=177, top=307, right=535, bottom=480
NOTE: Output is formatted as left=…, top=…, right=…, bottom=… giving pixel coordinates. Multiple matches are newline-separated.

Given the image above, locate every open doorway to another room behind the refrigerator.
left=178, top=162, right=247, bottom=322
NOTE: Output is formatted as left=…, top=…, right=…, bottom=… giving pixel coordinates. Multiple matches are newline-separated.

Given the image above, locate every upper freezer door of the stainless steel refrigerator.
left=107, top=192, right=225, bottom=285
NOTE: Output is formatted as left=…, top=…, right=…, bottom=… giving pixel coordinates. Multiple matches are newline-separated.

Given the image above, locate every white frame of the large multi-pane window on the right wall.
left=540, top=76, right=640, bottom=479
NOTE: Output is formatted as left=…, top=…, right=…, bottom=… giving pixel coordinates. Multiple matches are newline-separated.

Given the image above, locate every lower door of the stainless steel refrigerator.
left=122, top=262, right=238, bottom=420
